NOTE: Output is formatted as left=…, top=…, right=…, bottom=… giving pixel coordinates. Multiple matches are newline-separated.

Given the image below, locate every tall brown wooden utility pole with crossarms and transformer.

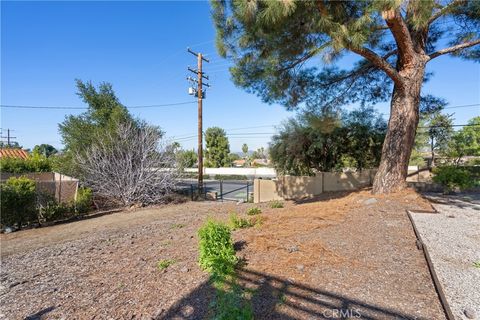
left=187, top=48, right=210, bottom=197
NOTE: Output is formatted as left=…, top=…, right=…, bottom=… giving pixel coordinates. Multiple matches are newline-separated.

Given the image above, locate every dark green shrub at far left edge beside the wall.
left=0, top=177, right=38, bottom=228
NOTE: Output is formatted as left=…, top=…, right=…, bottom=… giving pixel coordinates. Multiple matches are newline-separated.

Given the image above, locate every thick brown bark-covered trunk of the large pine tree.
left=373, top=62, right=425, bottom=193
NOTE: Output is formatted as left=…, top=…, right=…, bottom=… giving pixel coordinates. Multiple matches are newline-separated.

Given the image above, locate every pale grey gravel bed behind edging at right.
left=412, top=194, right=480, bottom=319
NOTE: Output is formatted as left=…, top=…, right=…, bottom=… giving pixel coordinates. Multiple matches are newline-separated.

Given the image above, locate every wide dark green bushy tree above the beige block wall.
left=270, top=108, right=386, bottom=175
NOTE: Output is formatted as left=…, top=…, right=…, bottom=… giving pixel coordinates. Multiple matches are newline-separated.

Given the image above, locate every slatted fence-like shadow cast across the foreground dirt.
left=156, top=268, right=428, bottom=320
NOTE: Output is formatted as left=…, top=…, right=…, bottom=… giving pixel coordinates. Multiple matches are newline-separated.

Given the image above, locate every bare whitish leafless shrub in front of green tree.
left=76, top=121, right=177, bottom=205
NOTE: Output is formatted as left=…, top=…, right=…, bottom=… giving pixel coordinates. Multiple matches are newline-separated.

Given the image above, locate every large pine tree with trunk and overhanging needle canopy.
left=212, top=0, right=480, bottom=193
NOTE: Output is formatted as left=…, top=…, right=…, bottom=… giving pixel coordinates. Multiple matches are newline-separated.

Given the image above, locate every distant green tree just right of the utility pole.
left=205, top=127, right=230, bottom=168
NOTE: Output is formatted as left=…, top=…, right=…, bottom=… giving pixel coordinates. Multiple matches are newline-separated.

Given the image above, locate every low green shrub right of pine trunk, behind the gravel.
left=433, top=166, right=473, bottom=192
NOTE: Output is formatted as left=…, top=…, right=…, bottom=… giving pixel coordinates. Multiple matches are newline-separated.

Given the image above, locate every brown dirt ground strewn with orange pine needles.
left=0, top=191, right=445, bottom=319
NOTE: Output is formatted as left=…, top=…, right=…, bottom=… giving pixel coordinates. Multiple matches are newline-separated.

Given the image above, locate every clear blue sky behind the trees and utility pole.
left=0, top=1, right=480, bottom=151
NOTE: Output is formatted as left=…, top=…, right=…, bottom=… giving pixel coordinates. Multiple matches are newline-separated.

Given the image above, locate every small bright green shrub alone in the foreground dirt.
left=198, top=219, right=237, bottom=280
